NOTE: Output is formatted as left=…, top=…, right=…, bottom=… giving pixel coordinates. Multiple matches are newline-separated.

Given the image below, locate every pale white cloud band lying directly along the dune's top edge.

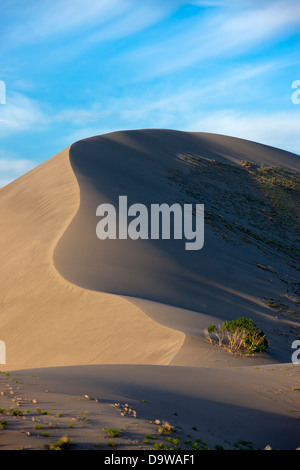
left=62, top=106, right=300, bottom=155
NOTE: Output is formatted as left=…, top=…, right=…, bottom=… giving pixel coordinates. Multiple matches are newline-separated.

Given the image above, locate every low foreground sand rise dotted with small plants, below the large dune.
left=0, top=364, right=300, bottom=455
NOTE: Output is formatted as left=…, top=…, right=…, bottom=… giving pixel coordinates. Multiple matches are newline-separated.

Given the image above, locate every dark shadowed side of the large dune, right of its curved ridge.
left=54, top=130, right=299, bottom=359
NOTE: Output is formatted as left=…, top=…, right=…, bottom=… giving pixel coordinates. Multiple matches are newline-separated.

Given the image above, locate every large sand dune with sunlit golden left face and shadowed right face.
left=0, top=130, right=299, bottom=370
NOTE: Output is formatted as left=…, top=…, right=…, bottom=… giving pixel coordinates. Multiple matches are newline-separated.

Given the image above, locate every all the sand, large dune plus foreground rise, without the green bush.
left=0, top=129, right=300, bottom=449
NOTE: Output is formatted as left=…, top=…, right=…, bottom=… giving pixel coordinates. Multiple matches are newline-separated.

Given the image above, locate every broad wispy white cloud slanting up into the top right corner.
left=123, top=0, right=300, bottom=81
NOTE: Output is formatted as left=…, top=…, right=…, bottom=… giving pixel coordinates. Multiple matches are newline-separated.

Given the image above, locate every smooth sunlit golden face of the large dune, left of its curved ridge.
left=0, top=148, right=184, bottom=370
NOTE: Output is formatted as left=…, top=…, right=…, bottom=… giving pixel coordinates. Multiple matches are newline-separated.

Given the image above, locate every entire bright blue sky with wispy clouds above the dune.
left=0, top=0, right=300, bottom=186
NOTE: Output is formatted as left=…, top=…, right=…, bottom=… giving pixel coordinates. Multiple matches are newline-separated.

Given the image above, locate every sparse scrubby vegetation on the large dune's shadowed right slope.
left=168, top=155, right=300, bottom=319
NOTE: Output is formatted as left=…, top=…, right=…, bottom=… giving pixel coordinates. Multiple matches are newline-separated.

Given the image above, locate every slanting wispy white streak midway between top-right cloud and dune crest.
left=108, top=60, right=290, bottom=121
